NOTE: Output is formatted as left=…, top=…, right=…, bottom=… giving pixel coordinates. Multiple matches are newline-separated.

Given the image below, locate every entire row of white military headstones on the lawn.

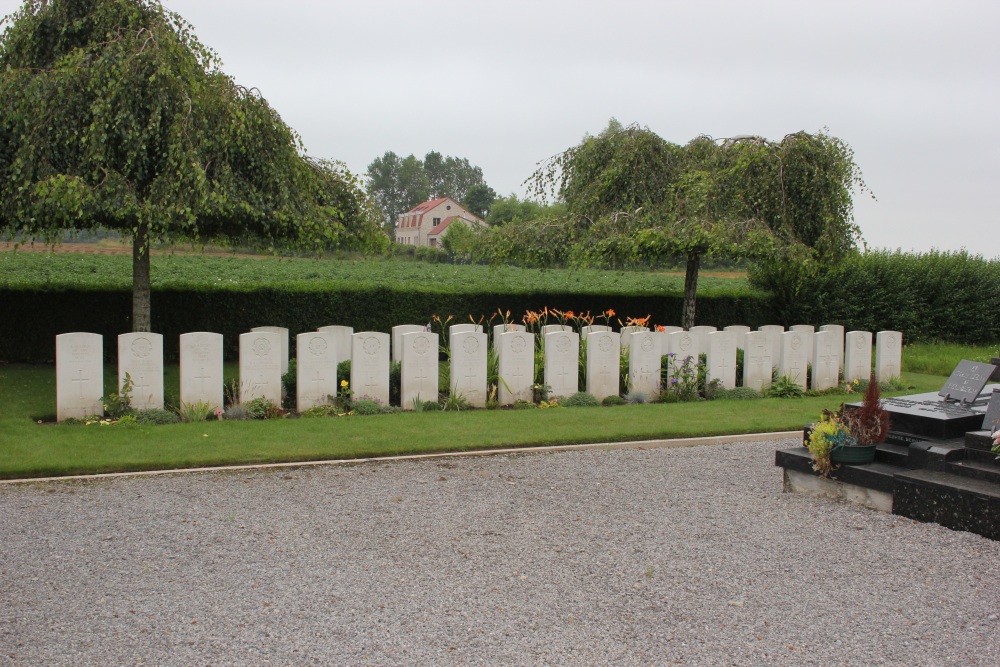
left=56, top=324, right=902, bottom=421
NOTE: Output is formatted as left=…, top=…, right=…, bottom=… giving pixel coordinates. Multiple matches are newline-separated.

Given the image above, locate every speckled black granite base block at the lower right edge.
left=892, top=470, right=1000, bottom=540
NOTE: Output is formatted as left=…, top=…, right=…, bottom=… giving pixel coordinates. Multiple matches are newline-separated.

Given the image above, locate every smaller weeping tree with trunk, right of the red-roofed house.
left=528, top=119, right=865, bottom=327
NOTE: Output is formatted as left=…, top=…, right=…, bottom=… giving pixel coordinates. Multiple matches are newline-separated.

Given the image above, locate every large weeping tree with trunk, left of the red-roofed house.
left=0, top=0, right=386, bottom=331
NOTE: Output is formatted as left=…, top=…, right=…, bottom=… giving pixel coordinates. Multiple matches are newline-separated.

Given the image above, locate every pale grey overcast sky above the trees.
left=0, top=0, right=1000, bottom=257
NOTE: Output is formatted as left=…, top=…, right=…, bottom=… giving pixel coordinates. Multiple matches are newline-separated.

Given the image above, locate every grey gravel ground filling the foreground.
left=0, top=441, right=1000, bottom=666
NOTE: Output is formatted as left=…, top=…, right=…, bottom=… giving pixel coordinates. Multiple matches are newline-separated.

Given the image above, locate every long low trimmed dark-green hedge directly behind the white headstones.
left=0, top=286, right=773, bottom=363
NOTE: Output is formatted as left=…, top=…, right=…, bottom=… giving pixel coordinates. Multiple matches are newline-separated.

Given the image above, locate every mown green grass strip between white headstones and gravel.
left=0, top=365, right=944, bottom=479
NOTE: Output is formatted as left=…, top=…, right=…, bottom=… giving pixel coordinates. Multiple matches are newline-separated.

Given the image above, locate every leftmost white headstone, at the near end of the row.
left=56, top=332, right=104, bottom=421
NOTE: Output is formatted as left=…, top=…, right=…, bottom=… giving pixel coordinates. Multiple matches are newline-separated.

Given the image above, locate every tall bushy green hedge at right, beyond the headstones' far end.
left=749, top=250, right=1000, bottom=344
